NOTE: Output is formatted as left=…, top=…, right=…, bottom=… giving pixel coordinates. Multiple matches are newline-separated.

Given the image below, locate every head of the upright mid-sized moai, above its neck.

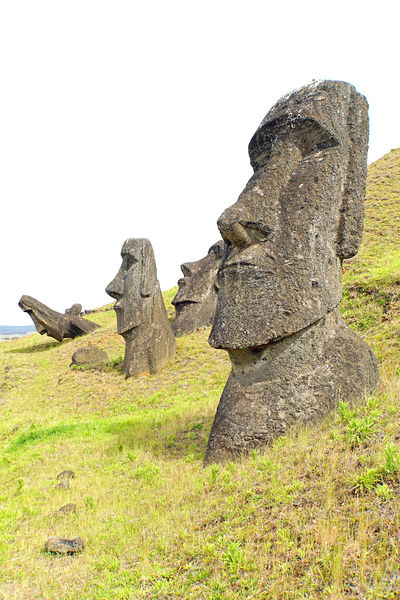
left=106, top=238, right=159, bottom=335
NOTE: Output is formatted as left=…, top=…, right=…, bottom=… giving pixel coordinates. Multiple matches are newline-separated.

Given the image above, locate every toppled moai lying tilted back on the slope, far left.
left=18, top=296, right=99, bottom=342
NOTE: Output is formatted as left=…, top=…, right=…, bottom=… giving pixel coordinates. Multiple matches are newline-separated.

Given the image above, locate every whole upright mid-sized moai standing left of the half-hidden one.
left=106, top=238, right=175, bottom=376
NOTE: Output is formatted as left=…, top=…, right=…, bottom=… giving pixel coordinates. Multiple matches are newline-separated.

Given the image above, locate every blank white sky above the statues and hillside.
left=0, top=0, right=400, bottom=325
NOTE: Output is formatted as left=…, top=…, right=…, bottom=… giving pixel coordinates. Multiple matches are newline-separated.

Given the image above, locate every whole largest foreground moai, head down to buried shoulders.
left=205, top=81, right=379, bottom=463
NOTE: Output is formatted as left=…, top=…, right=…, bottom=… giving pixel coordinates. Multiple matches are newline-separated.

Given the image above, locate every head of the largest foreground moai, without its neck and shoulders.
left=210, top=81, right=368, bottom=349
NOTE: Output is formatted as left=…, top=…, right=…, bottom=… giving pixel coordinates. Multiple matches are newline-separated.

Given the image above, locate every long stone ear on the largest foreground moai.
left=336, top=89, right=368, bottom=259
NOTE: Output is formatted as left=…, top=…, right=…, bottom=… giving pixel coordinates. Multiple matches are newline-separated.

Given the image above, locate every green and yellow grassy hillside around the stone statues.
left=0, top=150, right=400, bottom=600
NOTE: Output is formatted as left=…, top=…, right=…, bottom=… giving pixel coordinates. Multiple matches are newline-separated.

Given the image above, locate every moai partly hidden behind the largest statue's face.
left=172, top=240, right=224, bottom=337
